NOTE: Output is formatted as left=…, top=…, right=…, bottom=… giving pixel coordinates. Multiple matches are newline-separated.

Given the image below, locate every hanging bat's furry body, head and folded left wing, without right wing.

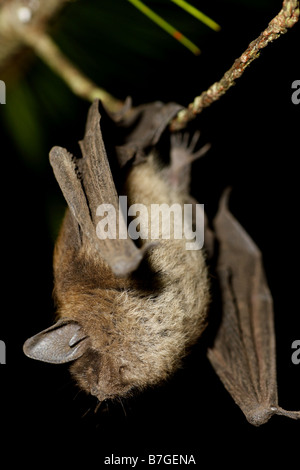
left=24, top=101, right=210, bottom=402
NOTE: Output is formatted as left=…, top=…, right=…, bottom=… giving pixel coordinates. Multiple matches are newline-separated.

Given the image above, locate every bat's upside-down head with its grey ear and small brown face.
left=23, top=312, right=142, bottom=401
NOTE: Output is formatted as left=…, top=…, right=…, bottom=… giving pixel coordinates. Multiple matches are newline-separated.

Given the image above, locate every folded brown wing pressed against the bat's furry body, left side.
left=50, top=101, right=143, bottom=276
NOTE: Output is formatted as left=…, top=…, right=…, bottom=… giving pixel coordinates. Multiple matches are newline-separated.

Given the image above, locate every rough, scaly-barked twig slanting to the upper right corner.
left=170, top=0, right=299, bottom=131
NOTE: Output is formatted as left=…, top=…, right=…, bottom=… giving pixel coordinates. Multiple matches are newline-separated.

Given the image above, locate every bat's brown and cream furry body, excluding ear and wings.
left=54, top=153, right=208, bottom=400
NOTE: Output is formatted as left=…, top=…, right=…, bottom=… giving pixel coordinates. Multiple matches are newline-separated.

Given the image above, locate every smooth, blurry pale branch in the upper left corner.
left=0, top=0, right=123, bottom=111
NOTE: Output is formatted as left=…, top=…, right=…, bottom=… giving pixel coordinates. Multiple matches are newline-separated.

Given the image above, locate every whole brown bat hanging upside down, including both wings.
left=24, top=102, right=300, bottom=426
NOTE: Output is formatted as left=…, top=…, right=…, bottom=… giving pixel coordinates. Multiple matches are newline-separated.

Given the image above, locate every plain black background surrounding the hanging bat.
left=0, top=1, right=300, bottom=468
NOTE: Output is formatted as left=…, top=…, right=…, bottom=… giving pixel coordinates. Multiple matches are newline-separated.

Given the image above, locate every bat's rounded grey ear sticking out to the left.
left=23, top=319, right=89, bottom=364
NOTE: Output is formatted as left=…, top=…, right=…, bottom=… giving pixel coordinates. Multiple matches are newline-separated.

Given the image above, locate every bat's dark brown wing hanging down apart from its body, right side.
left=208, top=191, right=300, bottom=426
